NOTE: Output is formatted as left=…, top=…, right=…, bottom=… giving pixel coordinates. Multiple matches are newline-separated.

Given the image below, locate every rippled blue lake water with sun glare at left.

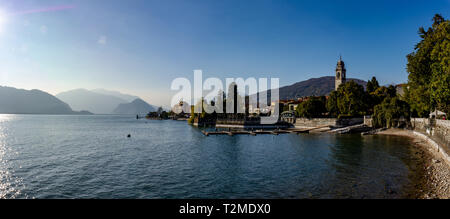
left=0, top=115, right=424, bottom=198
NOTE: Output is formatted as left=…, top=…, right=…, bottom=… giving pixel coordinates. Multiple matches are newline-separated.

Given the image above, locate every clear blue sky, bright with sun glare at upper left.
left=0, top=0, right=450, bottom=106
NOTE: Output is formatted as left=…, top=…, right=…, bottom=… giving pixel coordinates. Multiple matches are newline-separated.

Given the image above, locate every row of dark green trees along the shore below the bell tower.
left=296, top=77, right=410, bottom=126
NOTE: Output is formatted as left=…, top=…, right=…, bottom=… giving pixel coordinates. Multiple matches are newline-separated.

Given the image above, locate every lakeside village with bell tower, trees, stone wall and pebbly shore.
left=142, top=15, right=450, bottom=198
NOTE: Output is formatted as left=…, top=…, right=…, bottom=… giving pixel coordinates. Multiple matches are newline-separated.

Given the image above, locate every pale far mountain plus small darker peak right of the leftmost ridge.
left=56, top=89, right=156, bottom=114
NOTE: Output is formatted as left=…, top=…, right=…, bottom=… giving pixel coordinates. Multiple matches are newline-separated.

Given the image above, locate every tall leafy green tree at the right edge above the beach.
left=405, top=14, right=450, bottom=117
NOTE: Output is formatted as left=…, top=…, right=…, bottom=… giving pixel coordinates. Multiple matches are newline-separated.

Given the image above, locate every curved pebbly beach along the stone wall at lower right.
left=377, top=129, right=450, bottom=199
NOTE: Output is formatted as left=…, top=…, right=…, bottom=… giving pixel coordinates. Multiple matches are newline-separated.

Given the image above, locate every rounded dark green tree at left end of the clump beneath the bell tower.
left=297, top=97, right=327, bottom=118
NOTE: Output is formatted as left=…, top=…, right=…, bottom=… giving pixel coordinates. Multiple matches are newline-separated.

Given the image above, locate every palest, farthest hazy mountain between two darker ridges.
left=56, top=89, right=129, bottom=114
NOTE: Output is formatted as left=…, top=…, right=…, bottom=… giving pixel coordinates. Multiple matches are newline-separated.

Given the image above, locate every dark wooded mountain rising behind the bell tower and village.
left=251, top=76, right=367, bottom=102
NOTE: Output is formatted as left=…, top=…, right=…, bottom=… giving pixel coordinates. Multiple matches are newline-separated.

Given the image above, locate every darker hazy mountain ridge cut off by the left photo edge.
left=0, top=86, right=90, bottom=114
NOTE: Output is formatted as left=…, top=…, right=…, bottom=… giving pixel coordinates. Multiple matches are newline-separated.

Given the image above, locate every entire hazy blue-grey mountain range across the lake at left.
left=0, top=86, right=157, bottom=115
